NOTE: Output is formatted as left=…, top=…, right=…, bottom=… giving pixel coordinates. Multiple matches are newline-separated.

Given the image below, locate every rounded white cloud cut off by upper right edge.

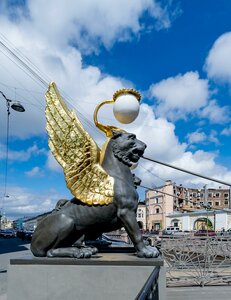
left=205, top=32, right=231, bottom=84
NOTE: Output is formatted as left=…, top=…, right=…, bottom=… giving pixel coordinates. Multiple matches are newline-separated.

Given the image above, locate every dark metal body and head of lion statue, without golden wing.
left=31, top=132, right=159, bottom=258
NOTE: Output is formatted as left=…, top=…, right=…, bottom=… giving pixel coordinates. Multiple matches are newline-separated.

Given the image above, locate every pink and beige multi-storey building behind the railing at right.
left=145, top=180, right=230, bottom=230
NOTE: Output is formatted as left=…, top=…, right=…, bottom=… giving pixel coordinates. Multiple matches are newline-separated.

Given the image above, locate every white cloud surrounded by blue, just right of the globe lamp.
left=150, top=72, right=209, bottom=120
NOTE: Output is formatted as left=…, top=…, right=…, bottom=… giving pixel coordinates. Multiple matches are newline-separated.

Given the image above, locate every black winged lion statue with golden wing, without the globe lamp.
left=31, top=83, right=159, bottom=258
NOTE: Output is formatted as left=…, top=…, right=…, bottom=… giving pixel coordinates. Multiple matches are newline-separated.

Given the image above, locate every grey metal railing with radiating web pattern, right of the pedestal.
left=161, top=236, right=231, bottom=286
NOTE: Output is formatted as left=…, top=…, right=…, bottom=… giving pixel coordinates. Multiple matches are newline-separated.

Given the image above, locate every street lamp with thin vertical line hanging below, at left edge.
left=0, top=91, right=25, bottom=211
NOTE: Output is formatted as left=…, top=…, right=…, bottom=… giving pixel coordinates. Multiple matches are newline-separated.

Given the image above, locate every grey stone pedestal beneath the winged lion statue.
left=7, top=253, right=166, bottom=300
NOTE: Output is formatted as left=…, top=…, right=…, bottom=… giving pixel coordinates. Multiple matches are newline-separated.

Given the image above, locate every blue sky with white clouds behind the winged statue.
left=0, top=0, right=231, bottom=218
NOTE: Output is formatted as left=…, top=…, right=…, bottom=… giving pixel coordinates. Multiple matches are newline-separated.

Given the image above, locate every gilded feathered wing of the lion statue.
left=46, top=82, right=114, bottom=205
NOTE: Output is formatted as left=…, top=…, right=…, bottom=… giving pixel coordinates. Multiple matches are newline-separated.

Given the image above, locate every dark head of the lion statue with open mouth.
left=111, top=132, right=146, bottom=167
